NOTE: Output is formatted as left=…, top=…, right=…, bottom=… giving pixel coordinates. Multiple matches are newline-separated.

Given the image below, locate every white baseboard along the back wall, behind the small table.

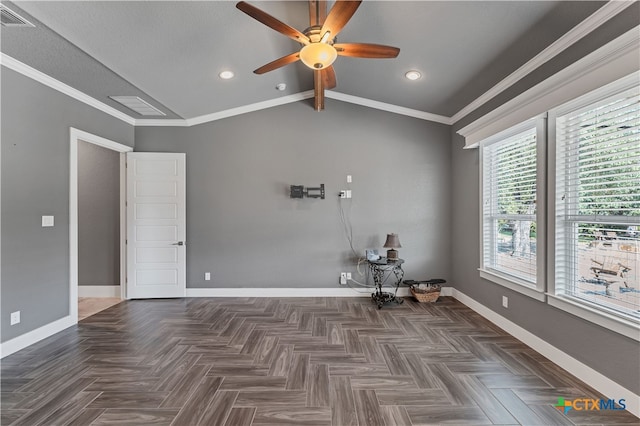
left=187, top=287, right=420, bottom=297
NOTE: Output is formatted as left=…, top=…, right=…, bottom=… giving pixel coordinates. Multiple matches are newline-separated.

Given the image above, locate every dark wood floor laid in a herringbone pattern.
left=0, top=297, right=639, bottom=426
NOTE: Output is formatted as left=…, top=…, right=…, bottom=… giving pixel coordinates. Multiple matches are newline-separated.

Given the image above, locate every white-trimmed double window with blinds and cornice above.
left=468, top=67, right=640, bottom=341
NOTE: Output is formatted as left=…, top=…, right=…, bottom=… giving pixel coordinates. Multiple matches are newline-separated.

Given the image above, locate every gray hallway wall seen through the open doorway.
left=78, top=141, right=120, bottom=285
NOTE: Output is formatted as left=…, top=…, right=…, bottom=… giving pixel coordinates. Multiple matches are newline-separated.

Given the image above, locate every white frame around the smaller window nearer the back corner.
left=478, top=118, right=547, bottom=302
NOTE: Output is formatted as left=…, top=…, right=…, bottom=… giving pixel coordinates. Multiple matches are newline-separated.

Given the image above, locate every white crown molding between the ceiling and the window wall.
left=451, top=0, right=635, bottom=124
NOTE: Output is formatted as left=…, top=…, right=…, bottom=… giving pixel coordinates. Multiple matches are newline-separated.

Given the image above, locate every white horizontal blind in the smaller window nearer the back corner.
left=482, top=128, right=537, bottom=286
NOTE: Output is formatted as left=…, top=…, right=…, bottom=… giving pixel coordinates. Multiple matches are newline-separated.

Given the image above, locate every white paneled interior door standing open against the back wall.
left=127, top=152, right=187, bottom=299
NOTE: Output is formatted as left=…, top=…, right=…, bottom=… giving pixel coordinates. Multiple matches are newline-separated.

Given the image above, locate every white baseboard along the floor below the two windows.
left=453, top=289, right=640, bottom=417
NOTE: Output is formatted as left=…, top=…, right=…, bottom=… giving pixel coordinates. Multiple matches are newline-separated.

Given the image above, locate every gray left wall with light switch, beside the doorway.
left=0, top=68, right=134, bottom=342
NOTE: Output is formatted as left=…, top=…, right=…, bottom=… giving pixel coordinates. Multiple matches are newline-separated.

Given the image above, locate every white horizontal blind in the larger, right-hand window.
left=555, top=87, right=640, bottom=318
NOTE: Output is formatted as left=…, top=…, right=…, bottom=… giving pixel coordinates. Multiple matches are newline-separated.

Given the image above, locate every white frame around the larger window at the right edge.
left=546, top=73, right=640, bottom=341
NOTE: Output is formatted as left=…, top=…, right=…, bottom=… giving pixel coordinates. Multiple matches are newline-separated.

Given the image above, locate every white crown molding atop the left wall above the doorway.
left=0, top=52, right=136, bottom=125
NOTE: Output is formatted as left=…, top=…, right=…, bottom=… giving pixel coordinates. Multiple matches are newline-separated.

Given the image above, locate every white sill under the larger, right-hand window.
left=547, top=294, right=640, bottom=342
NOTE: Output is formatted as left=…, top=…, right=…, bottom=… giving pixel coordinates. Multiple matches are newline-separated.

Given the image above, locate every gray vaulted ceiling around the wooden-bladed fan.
left=1, top=0, right=620, bottom=122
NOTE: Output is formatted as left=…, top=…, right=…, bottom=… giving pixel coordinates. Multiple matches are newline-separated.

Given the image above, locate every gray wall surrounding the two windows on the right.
left=451, top=5, right=640, bottom=392
